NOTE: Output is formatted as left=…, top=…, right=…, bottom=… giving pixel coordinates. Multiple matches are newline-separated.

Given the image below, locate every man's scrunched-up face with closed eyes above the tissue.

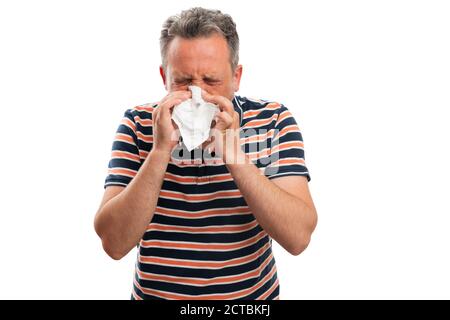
left=160, top=34, right=242, bottom=100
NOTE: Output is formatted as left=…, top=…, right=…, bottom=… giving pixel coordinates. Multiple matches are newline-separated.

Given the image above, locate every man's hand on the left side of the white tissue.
left=152, top=91, right=192, bottom=153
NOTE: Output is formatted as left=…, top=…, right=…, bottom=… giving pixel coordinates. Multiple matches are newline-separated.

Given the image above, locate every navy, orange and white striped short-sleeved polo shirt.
left=104, top=95, right=310, bottom=300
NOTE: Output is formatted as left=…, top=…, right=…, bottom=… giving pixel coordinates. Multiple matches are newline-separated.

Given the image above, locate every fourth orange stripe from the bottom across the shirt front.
left=141, top=231, right=267, bottom=251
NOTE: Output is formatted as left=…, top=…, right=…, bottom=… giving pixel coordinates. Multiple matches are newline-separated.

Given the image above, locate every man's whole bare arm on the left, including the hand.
left=94, top=91, right=191, bottom=260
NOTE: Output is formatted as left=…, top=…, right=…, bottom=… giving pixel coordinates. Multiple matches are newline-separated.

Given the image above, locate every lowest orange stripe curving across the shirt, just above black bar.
left=134, top=265, right=276, bottom=300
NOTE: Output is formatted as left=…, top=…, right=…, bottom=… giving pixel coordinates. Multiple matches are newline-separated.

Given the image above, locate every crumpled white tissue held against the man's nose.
left=172, top=86, right=219, bottom=151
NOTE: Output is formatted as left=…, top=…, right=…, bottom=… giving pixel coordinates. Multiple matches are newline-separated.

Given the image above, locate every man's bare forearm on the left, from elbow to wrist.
left=98, top=150, right=170, bottom=258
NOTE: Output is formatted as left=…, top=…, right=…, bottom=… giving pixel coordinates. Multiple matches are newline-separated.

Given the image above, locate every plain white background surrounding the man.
left=0, top=0, right=450, bottom=299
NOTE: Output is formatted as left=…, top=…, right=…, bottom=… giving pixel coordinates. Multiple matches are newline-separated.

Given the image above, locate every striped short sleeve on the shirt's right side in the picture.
left=264, top=105, right=311, bottom=181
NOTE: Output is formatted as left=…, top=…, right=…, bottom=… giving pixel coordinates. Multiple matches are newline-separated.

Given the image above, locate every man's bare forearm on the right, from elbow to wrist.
left=227, top=152, right=316, bottom=255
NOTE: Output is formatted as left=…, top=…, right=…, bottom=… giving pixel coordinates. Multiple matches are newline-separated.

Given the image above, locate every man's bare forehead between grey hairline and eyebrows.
left=167, top=34, right=230, bottom=76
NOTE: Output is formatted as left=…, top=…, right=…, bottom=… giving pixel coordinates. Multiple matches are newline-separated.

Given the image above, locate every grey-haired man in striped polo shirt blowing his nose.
left=95, top=8, right=317, bottom=299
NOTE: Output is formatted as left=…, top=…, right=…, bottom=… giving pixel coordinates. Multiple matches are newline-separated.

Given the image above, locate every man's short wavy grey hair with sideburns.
left=159, top=7, right=239, bottom=70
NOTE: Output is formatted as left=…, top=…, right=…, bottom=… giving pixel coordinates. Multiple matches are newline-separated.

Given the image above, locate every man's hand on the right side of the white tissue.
left=202, top=90, right=242, bottom=162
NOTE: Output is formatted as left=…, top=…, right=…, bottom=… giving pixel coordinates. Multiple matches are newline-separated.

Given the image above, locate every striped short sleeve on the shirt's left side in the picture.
left=104, top=109, right=141, bottom=188
